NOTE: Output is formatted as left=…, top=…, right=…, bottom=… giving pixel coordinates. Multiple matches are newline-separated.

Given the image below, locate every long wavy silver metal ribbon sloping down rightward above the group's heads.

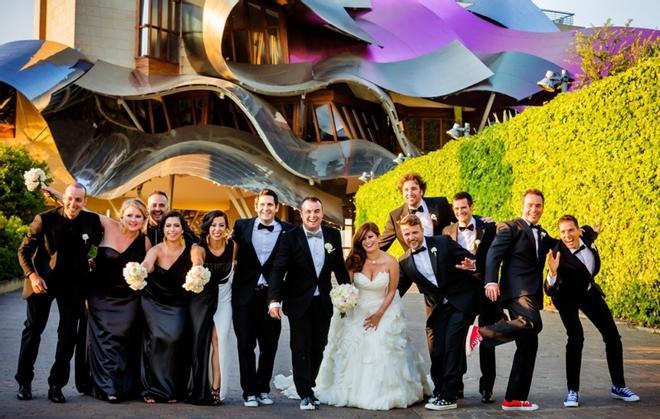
left=76, top=61, right=395, bottom=180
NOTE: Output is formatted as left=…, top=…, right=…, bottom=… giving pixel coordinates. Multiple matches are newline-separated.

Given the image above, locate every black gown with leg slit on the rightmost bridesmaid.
left=187, top=241, right=234, bottom=404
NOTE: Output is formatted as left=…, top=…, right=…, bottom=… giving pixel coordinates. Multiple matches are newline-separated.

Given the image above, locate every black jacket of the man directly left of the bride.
left=268, top=226, right=350, bottom=318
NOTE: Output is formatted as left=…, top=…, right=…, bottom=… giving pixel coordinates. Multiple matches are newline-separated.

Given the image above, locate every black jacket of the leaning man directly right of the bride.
left=399, top=236, right=476, bottom=318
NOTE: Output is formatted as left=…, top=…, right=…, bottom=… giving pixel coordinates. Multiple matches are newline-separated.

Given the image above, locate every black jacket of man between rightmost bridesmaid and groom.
left=232, top=217, right=293, bottom=306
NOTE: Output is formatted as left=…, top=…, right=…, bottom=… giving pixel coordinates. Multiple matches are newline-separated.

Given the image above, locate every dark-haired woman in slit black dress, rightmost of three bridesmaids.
left=187, top=210, right=234, bottom=405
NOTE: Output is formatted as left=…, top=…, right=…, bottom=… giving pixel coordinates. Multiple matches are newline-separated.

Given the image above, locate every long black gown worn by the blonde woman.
left=87, top=234, right=146, bottom=398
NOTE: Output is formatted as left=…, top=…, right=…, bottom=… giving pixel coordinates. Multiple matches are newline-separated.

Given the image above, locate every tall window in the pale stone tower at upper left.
left=138, top=0, right=181, bottom=63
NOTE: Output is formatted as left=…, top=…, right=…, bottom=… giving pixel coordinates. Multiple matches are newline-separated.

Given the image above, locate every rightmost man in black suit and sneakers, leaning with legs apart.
left=545, top=215, right=639, bottom=407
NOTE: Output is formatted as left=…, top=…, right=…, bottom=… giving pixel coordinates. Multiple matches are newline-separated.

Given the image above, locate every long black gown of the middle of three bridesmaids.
left=141, top=246, right=192, bottom=401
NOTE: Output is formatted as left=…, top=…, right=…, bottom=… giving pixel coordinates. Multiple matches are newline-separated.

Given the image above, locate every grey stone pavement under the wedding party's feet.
left=0, top=292, right=660, bottom=419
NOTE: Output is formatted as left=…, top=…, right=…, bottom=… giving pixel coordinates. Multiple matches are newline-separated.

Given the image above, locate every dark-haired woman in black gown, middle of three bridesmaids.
left=141, top=211, right=192, bottom=403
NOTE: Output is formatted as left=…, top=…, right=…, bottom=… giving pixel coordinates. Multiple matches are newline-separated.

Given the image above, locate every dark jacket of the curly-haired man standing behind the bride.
left=379, top=197, right=456, bottom=251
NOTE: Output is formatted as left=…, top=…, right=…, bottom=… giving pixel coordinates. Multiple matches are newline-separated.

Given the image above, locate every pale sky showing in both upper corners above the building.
left=0, top=0, right=660, bottom=44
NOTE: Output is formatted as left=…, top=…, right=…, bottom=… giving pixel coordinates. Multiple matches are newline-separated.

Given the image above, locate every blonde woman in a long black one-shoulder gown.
left=87, top=199, right=151, bottom=403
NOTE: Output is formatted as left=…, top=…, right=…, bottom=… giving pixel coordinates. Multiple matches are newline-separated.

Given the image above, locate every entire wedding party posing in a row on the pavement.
left=15, top=173, right=639, bottom=411
